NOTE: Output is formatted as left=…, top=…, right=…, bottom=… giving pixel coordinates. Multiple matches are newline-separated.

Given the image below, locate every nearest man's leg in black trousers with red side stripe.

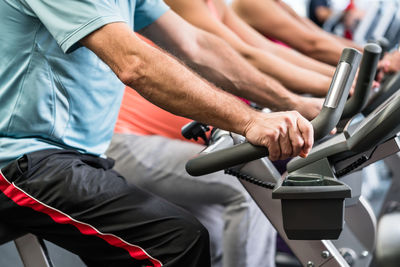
left=0, top=150, right=210, bottom=267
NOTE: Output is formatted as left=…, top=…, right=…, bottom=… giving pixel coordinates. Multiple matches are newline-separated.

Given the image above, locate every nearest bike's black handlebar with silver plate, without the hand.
left=186, top=48, right=361, bottom=176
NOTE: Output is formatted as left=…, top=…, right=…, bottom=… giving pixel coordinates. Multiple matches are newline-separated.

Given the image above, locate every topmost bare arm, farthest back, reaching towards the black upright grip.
left=233, top=0, right=352, bottom=65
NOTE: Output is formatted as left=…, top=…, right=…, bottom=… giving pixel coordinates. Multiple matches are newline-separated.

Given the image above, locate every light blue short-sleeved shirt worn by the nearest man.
left=0, top=0, right=168, bottom=167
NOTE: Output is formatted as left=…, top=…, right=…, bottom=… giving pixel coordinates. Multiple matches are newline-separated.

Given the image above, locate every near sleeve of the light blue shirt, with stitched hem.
left=24, top=0, right=125, bottom=53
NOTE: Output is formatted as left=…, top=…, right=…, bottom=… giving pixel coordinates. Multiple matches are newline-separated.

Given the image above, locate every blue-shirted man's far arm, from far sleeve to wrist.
left=141, top=10, right=301, bottom=110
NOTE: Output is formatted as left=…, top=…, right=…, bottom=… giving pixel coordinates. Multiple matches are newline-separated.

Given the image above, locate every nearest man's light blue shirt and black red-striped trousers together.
left=0, top=0, right=216, bottom=266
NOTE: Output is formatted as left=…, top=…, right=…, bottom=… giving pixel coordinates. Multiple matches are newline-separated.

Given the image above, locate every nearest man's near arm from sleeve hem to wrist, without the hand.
left=81, top=23, right=255, bottom=134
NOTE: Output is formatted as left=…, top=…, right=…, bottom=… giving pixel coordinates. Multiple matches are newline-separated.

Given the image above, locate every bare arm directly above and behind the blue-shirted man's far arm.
left=162, top=0, right=330, bottom=96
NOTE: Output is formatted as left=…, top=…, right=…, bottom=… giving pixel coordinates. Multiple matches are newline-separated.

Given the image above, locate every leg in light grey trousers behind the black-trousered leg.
left=106, top=134, right=275, bottom=267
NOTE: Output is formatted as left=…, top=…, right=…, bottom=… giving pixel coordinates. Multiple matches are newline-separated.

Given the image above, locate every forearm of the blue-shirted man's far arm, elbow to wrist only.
left=177, top=33, right=297, bottom=110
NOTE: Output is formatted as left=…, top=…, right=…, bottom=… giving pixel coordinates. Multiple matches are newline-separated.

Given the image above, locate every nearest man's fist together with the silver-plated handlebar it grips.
left=186, top=48, right=361, bottom=176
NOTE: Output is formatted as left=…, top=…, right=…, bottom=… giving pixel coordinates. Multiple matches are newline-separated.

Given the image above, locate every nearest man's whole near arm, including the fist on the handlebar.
left=81, top=20, right=313, bottom=159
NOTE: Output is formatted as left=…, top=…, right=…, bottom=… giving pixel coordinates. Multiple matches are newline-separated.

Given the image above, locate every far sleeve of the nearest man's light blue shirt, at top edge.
left=134, top=0, right=169, bottom=31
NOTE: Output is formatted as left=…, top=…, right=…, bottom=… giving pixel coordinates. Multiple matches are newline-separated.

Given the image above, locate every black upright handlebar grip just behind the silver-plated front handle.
left=342, top=44, right=382, bottom=119
